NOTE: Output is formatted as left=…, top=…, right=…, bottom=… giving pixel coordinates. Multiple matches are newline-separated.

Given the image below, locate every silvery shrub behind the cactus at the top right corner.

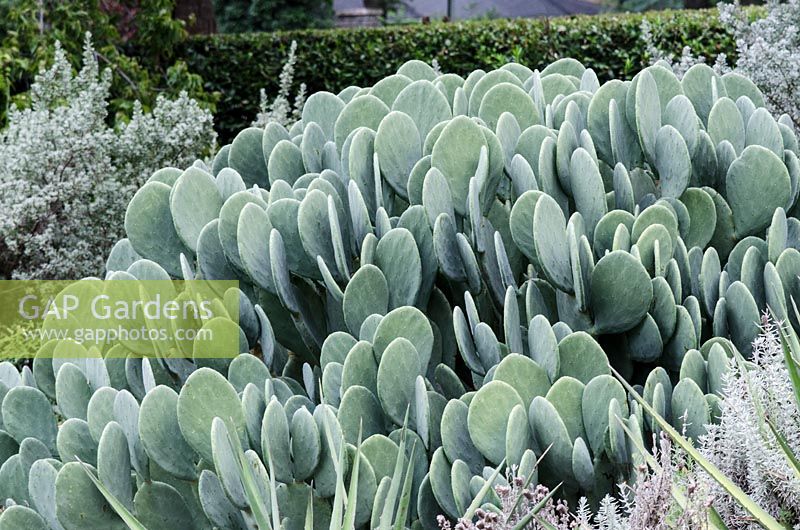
left=641, top=0, right=800, bottom=126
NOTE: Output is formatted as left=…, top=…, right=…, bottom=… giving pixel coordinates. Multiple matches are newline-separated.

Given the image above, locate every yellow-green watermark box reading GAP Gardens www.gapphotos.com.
left=0, top=279, right=242, bottom=360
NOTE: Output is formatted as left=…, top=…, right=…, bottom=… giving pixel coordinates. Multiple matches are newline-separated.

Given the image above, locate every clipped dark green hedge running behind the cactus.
left=185, top=9, right=735, bottom=141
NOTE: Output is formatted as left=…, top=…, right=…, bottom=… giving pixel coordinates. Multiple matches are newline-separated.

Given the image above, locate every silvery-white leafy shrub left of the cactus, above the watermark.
left=0, top=37, right=216, bottom=279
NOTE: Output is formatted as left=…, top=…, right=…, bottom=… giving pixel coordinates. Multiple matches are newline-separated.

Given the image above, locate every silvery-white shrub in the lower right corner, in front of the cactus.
left=701, top=320, right=800, bottom=530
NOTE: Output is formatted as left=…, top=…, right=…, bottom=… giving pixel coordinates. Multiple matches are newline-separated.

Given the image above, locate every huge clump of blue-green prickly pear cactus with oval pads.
left=0, top=55, right=800, bottom=530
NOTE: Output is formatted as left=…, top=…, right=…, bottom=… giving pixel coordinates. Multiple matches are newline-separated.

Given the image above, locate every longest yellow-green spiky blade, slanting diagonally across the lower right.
left=611, top=368, right=786, bottom=530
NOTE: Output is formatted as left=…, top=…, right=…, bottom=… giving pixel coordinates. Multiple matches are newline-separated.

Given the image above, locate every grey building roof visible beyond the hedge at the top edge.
left=334, top=0, right=600, bottom=19
